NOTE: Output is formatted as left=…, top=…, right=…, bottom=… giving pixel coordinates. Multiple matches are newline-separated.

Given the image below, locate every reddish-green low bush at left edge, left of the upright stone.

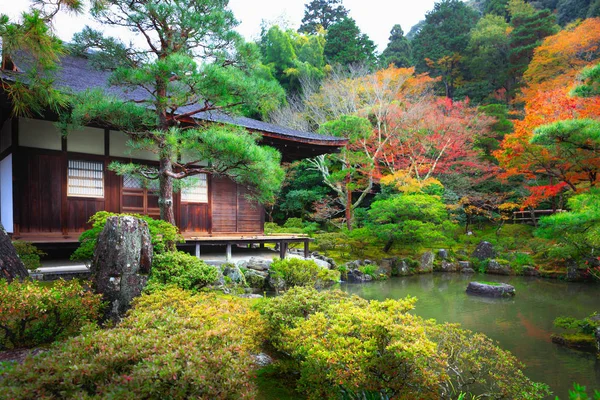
left=0, top=279, right=101, bottom=350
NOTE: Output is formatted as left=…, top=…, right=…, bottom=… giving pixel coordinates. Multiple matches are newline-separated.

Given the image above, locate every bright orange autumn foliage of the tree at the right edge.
left=494, top=18, right=600, bottom=206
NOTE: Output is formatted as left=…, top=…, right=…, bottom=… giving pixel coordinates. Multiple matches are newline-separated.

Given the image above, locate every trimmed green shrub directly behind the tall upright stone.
left=71, top=211, right=183, bottom=261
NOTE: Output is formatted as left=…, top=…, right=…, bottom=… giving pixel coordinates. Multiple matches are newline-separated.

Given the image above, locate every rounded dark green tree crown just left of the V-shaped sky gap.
left=324, top=18, right=376, bottom=66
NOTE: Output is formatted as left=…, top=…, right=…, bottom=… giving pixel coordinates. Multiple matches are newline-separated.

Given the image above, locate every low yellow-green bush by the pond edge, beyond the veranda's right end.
left=269, top=258, right=340, bottom=289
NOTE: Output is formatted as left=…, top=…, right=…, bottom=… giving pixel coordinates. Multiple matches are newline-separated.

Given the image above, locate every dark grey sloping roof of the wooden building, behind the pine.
left=2, top=55, right=346, bottom=147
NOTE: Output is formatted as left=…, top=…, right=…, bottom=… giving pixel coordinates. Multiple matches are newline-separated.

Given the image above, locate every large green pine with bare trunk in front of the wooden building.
left=63, top=0, right=284, bottom=223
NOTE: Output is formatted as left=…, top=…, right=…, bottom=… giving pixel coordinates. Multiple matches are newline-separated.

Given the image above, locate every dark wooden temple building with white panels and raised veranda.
left=0, top=56, right=346, bottom=258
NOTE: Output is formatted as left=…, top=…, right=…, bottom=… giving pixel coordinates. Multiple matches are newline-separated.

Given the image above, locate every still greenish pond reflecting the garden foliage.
left=340, top=274, right=600, bottom=399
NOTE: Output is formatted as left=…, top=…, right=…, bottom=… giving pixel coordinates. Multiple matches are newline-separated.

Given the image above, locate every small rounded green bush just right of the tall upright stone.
left=146, top=251, right=219, bottom=291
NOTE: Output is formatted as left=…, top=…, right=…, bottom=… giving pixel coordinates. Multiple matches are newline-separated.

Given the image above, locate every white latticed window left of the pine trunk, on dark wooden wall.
left=67, top=160, right=104, bottom=197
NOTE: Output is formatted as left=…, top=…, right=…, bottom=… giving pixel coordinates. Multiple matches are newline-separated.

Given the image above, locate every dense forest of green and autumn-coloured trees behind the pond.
left=246, top=0, right=600, bottom=272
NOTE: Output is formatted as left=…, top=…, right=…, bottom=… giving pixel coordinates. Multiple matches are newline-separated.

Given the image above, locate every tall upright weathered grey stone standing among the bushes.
left=90, top=216, right=152, bottom=322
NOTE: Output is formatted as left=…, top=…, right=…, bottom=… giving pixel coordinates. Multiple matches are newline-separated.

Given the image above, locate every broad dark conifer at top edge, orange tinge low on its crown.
left=412, top=0, right=479, bottom=98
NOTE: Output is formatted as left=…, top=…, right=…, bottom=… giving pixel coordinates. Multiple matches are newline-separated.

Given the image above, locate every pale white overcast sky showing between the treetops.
left=0, top=0, right=435, bottom=52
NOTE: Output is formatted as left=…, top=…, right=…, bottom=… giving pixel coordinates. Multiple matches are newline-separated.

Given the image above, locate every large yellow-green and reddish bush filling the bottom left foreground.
left=0, top=289, right=264, bottom=400
